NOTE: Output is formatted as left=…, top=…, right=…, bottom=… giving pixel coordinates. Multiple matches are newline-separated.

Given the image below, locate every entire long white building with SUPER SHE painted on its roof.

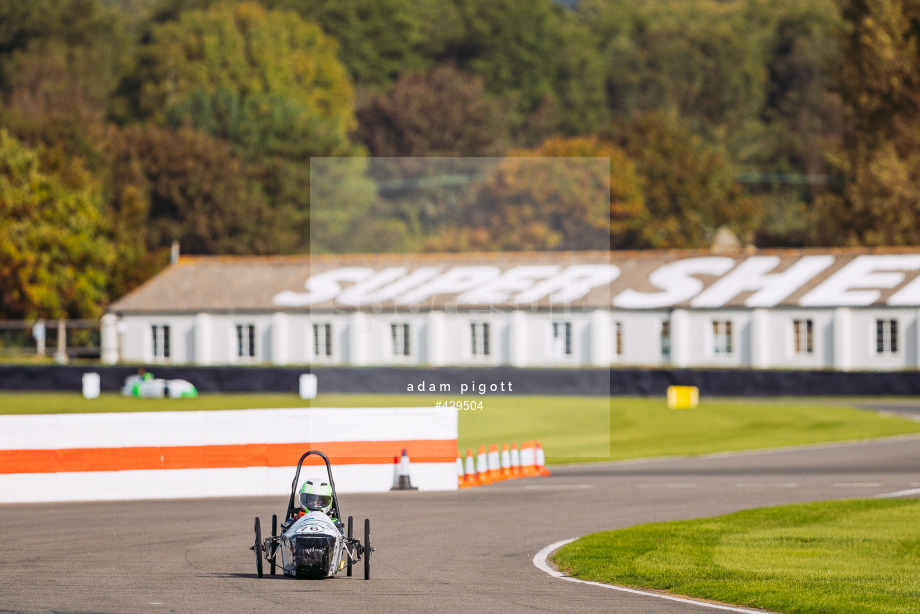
left=103, top=249, right=920, bottom=371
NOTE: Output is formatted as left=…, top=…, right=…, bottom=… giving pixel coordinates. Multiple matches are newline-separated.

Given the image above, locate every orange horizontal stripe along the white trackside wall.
left=0, top=439, right=457, bottom=474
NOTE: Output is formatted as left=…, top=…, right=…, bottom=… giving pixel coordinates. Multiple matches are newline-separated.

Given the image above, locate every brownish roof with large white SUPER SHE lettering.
left=109, top=248, right=920, bottom=313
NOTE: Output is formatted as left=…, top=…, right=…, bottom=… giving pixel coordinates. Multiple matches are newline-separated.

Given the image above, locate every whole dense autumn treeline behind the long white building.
left=0, top=0, right=920, bottom=318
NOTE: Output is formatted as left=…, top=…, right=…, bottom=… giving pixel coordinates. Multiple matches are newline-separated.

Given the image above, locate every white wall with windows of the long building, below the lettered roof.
left=111, top=307, right=920, bottom=371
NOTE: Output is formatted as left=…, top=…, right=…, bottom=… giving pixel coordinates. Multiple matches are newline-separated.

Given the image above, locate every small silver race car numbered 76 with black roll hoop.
left=250, top=450, right=374, bottom=580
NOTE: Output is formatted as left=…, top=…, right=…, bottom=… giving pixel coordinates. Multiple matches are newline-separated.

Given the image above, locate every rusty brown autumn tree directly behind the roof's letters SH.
left=614, top=112, right=761, bottom=249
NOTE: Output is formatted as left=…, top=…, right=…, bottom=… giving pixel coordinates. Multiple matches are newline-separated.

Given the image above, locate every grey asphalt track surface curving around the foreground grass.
left=0, top=437, right=920, bottom=614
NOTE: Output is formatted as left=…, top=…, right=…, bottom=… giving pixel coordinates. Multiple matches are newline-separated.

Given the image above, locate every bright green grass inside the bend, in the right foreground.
left=552, top=499, right=920, bottom=614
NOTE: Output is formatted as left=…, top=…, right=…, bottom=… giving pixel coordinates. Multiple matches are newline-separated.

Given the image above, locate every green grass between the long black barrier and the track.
left=0, top=393, right=920, bottom=464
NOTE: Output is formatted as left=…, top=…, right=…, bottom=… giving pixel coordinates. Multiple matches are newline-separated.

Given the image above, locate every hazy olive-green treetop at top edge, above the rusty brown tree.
left=576, top=0, right=767, bottom=144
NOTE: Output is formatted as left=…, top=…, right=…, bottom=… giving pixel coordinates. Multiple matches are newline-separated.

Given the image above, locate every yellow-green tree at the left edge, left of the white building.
left=0, top=130, right=115, bottom=318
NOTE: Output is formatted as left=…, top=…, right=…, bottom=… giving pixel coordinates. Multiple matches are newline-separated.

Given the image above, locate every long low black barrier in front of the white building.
left=0, top=365, right=920, bottom=399
